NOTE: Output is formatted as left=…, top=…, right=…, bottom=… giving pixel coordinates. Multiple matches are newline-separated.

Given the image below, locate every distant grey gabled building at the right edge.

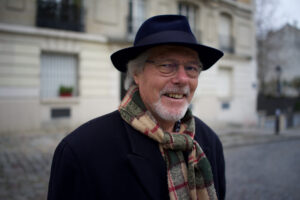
left=265, top=24, right=300, bottom=97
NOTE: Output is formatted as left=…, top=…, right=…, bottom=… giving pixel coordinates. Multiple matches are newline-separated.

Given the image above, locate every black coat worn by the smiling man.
left=48, top=111, right=225, bottom=200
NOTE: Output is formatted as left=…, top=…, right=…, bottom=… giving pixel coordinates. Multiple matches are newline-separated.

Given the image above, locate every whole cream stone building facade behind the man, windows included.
left=0, top=0, right=257, bottom=132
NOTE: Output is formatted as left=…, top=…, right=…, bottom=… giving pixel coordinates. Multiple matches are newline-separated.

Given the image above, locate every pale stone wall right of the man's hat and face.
left=193, top=1, right=257, bottom=127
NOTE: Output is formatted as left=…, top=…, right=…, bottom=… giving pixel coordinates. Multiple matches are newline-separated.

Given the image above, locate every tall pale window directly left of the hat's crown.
left=128, top=0, right=146, bottom=39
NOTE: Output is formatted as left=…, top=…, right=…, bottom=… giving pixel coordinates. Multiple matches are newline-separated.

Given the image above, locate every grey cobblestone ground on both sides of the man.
left=0, top=129, right=300, bottom=200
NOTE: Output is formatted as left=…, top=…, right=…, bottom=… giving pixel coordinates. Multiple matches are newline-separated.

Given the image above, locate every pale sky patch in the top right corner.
left=276, top=0, right=300, bottom=28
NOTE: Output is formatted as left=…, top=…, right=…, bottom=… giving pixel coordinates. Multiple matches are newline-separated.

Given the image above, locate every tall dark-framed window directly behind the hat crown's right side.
left=178, top=2, right=201, bottom=41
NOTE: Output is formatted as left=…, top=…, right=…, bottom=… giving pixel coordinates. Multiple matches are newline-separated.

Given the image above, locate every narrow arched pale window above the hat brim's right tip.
left=219, top=13, right=234, bottom=53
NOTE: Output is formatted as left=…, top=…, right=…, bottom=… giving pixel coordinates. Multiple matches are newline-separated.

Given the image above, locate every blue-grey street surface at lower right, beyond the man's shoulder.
left=225, top=139, right=300, bottom=200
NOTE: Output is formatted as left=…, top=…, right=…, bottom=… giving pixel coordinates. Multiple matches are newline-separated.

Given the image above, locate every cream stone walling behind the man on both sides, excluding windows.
left=0, top=0, right=256, bottom=132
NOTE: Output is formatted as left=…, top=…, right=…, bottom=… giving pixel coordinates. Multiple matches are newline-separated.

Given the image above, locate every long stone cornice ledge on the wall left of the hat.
left=0, top=23, right=108, bottom=43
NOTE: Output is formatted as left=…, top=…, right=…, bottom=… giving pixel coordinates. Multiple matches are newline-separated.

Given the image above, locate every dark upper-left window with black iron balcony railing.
left=36, top=0, right=84, bottom=32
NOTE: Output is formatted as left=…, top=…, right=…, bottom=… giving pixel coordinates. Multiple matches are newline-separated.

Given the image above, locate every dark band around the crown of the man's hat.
left=134, top=31, right=197, bottom=46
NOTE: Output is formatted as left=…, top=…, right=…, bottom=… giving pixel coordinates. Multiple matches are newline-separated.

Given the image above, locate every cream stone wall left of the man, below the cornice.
left=0, top=25, right=119, bottom=132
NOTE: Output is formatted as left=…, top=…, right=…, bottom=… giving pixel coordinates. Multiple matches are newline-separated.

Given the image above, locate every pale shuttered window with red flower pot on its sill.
left=40, top=52, right=78, bottom=99
